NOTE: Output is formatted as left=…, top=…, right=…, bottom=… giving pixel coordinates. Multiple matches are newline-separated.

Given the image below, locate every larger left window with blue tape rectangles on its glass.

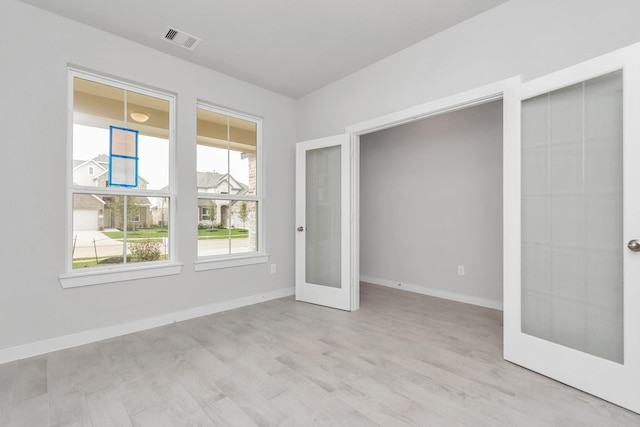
left=61, top=70, right=174, bottom=286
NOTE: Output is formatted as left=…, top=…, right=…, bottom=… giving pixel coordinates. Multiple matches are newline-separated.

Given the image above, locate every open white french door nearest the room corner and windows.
left=295, top=134, right=359, bottom=311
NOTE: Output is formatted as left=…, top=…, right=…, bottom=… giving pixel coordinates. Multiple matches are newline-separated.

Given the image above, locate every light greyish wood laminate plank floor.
left=0, top=284, right=640, bottom=427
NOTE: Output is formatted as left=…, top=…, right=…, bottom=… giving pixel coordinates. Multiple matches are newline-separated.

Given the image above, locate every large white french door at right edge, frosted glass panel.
left=504, top=46, right=640, bottom=413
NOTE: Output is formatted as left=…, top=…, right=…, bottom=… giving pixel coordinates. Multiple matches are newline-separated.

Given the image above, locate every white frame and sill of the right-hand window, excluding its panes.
left=194, top=100, right=269, bottom=271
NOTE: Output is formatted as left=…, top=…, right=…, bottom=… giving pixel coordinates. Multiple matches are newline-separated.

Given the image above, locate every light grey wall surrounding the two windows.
left=0, top=0, right=296, bottom=355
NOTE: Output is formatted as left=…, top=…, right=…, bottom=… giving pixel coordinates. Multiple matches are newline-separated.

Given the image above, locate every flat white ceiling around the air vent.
left=16, top=0, right=507, bottom=99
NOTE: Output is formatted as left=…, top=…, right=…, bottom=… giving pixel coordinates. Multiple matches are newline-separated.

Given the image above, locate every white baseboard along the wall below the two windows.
left=0, top=287, right=295, bottom=364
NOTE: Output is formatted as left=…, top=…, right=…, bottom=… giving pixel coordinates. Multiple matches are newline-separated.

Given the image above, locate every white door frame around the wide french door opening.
left=345, top=76, right=521, bottom=308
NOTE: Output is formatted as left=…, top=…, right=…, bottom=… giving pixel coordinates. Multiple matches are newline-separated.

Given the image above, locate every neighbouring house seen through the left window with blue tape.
left=73, top=154, right=153, bottom=231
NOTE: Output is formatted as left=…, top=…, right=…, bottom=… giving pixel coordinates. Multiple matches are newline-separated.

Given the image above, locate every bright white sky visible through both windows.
left=73, top=124, right=249, bottom=190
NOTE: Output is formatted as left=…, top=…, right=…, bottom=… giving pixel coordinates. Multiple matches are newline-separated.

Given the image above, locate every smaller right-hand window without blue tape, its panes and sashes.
left=197, top=104, right=262, bottom=260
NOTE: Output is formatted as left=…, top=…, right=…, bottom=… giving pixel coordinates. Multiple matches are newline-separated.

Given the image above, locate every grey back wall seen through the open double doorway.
left=360, top=101, right=502, bottom=308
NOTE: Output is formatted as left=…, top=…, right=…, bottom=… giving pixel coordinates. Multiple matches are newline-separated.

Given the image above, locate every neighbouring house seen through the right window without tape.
left=197, top=171, right=249, bottom=227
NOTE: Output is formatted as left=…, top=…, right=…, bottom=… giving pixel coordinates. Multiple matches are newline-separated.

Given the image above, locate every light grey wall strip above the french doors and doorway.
left=298, top=0, right=640, bottom=140
